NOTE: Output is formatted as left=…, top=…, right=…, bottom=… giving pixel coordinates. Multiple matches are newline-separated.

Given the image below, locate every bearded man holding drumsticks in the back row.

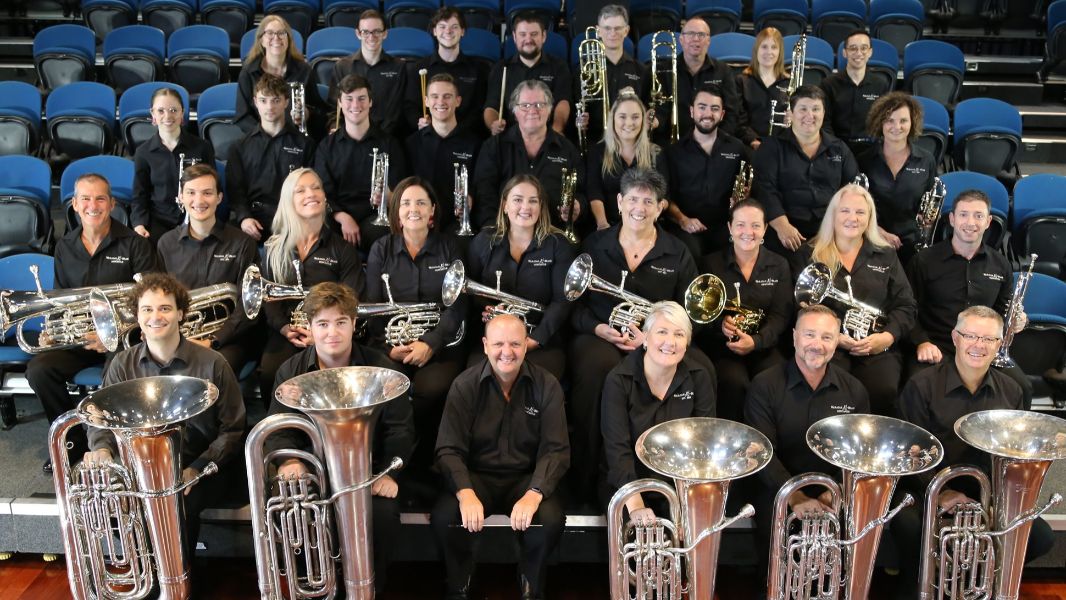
left=482, top=12, right=571, bottom=136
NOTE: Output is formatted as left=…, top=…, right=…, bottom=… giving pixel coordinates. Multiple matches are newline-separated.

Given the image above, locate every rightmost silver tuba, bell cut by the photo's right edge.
left=919, top=410, right=1066, bottom=600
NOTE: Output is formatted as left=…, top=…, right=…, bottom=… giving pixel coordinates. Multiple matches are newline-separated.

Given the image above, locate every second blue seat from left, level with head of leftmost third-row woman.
left=45, top=81, right=115, bottom=159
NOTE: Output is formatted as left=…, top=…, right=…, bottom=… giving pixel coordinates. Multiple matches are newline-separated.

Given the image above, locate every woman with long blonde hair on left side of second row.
left=259, top=168, right=366, bottom=404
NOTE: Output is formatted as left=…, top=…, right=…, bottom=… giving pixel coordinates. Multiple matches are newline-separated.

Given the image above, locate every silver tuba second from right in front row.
left=766, top=415, right=943, bottom=600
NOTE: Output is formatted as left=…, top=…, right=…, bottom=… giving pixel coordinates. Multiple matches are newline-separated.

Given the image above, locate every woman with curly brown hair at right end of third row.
left=858, top=92, right=937, bottom=264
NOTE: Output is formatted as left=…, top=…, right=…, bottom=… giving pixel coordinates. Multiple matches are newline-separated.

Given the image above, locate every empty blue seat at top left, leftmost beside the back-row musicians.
left=33, top=25, right=96, bottom=91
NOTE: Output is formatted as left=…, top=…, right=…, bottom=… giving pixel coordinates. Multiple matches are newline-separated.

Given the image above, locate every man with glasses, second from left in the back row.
left=329, top=9, right=407, bottom=135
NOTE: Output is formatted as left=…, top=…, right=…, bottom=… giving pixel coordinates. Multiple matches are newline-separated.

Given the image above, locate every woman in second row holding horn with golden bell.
left=699, top=198, right=793, bottom=421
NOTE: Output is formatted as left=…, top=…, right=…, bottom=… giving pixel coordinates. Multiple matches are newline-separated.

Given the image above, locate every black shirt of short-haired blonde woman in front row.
left=600, top=348, right=717, bottom=489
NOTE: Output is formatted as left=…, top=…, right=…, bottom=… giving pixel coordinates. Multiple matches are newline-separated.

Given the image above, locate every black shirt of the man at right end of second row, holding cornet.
left=907, top=240, right=1014, bottom=352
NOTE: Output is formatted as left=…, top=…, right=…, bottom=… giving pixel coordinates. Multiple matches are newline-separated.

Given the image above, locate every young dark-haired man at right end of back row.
left=822, top=29, right=892, bottom=156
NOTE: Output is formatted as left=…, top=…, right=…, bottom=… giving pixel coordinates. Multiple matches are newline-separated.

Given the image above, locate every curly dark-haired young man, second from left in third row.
left=227, top=74, right=314, bottom=242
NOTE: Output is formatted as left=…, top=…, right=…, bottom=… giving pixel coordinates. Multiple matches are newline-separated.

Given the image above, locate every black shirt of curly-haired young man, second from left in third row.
left=226, top=125, right=314, bottom=229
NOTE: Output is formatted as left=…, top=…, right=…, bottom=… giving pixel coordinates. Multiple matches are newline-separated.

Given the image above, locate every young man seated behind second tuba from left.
left=264, top=281, right=415, bottom=594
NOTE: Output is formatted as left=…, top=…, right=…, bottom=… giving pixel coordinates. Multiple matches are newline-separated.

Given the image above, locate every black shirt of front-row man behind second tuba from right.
left=744, top=360, right=870, bottom=491
